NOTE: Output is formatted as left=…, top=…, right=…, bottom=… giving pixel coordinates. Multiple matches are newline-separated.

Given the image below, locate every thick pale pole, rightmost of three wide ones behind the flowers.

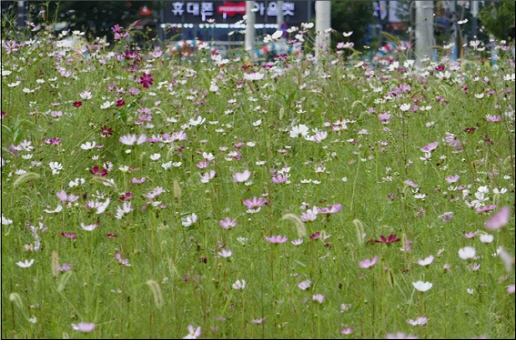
left=415, top=1, right=434, bottom=66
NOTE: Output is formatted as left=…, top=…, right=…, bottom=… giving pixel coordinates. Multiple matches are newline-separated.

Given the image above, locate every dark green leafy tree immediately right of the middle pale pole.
left=331, top=1, right=374, bottom=49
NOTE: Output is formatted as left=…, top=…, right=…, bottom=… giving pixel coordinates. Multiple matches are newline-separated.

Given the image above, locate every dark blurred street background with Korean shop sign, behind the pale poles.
left=1, top=1, right=515, bottom=57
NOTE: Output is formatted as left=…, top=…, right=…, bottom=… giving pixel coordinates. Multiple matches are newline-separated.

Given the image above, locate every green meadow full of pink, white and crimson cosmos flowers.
left=1, top=15, right=515, bottom=339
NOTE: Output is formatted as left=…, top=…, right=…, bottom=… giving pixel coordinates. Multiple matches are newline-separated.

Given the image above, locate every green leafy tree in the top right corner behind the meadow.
left=478, top=1, right=516, bottom=39
